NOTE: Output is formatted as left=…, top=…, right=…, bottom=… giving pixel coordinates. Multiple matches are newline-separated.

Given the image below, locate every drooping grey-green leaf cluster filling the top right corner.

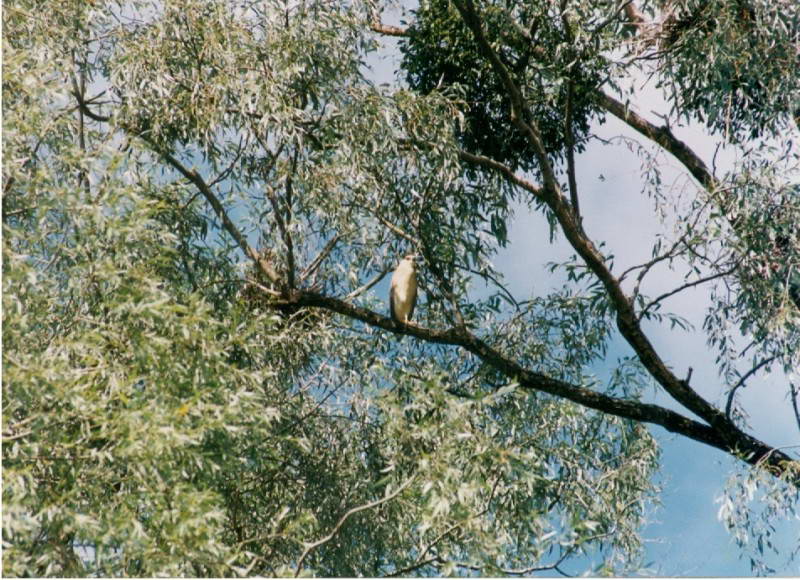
left=662, top=0, right=800, bottom=141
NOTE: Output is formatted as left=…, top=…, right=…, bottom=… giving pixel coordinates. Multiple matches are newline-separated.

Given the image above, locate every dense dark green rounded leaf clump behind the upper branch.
left=400, top=0, right=607, bottom=170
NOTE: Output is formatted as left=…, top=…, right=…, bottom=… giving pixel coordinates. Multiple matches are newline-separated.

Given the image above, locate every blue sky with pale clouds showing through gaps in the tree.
left=368, top=6, right=800, bottom=576
